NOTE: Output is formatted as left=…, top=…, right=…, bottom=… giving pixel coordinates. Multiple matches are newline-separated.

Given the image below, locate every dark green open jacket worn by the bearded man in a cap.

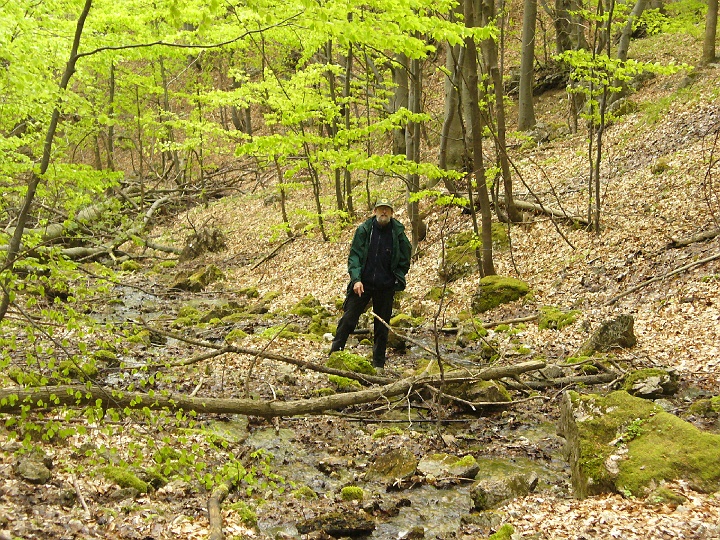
left=348, top=217, right=412, bottom=291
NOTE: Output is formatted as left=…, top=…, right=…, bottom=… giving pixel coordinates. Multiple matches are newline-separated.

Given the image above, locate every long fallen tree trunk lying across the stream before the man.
left=0, top=360, right=545, bottom=418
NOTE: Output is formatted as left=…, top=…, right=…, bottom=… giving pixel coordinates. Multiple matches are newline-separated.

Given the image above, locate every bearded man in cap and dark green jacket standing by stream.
left=330, top=199, right=411, bottom=373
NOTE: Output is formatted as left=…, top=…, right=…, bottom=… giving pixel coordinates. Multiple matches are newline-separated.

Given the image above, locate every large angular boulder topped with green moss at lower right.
left=560, top=390, right=720, bottom=498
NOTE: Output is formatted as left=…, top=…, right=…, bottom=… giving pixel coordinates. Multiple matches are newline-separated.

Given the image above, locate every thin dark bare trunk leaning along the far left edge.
left=0, top=0, right=92, bottom=321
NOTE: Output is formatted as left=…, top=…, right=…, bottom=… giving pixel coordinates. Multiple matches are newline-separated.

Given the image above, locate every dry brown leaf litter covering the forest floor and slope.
left=0, top=28, right=720, bottom=540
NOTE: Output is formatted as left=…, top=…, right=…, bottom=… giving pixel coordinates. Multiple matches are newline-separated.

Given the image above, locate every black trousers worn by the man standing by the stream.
left=330, top=289, right=395, bottom=367
